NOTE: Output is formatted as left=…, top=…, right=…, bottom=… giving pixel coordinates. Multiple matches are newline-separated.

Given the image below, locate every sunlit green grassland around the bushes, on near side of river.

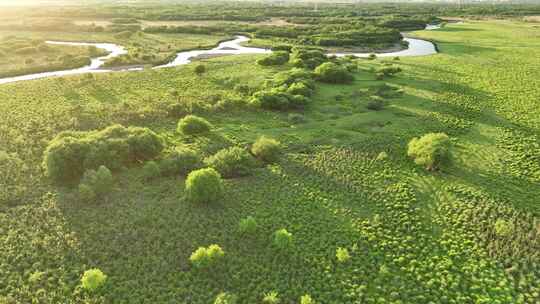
left=0, top=21, right=540, bottom=304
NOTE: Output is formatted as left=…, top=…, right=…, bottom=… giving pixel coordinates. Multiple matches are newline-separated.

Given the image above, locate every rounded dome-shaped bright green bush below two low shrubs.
left=185, top=168, right=223, bottom=203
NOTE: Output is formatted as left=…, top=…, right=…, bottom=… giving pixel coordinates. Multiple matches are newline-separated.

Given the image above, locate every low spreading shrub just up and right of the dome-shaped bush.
left=205, top=147, right=256, bottom=177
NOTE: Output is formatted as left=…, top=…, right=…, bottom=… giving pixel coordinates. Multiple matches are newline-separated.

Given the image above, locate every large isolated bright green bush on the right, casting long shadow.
left=407, top=133, right=451, bottom=171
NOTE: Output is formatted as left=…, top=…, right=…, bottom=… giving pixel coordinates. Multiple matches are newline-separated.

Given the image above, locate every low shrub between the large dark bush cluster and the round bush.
left=159, top=148, right=202, bottom=176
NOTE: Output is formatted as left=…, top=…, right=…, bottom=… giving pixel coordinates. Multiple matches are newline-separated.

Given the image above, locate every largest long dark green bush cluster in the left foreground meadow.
left=43, top=125, right=164, bottom=182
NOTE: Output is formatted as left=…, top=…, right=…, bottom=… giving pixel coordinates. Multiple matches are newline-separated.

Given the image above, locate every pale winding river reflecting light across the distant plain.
left=0, top=25, right=439, bottom=84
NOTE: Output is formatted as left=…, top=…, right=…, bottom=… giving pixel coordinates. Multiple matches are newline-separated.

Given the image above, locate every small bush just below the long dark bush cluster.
left=79, top=166, right=113, bottom=202
